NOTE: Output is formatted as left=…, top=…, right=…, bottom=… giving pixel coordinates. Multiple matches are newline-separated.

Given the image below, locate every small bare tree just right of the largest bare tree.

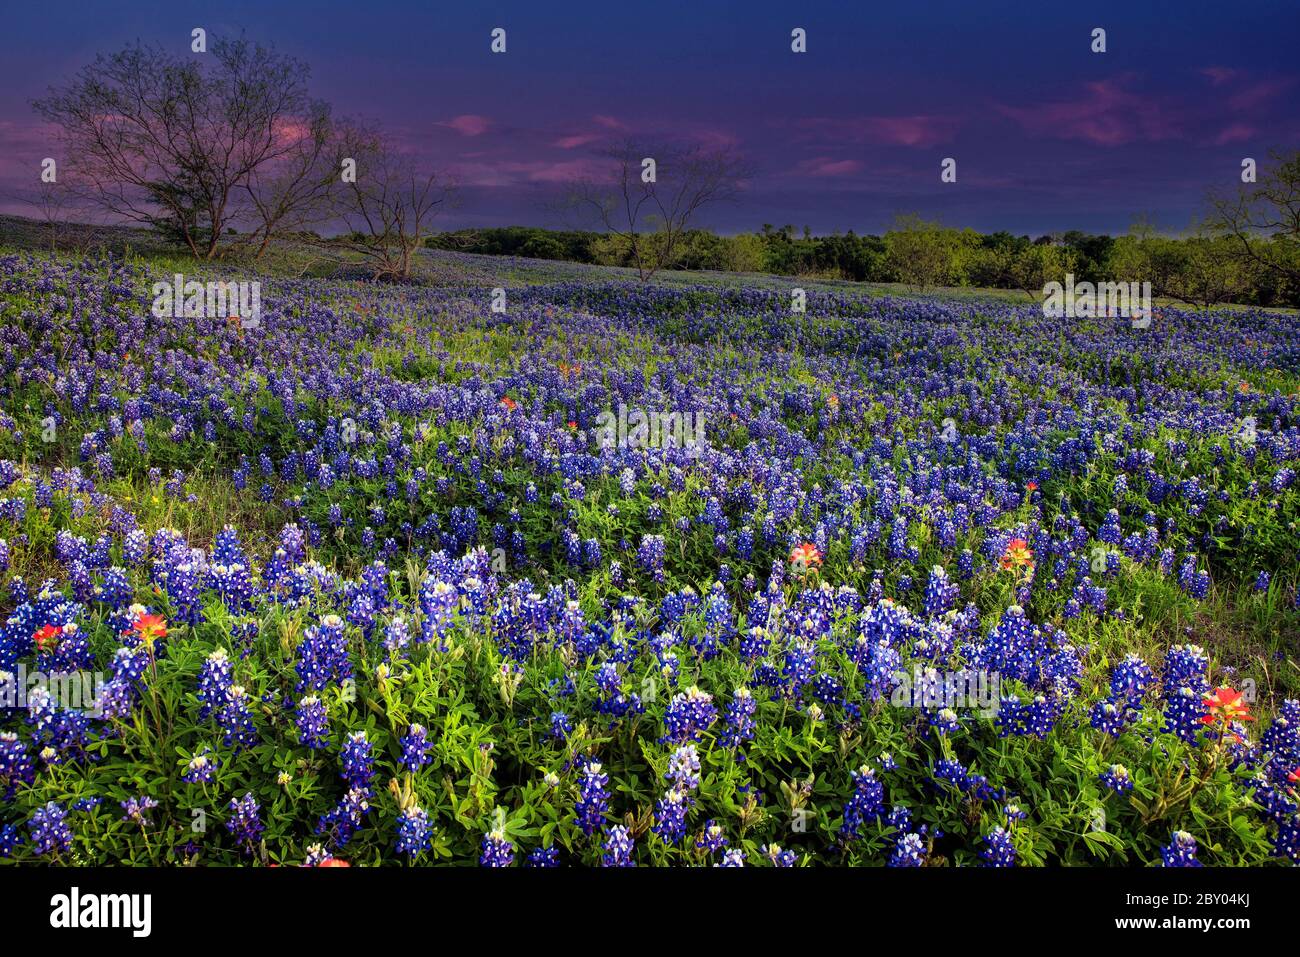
left=330, top=126, right=454, bottom=280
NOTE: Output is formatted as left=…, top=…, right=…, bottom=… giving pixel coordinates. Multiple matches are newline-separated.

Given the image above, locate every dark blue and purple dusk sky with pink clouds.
left=0, top=0, right=1300, bottom=234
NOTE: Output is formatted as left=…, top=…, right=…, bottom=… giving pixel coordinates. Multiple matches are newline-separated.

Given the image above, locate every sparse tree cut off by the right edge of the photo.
left=1205, top=151, right=1300, bottom=280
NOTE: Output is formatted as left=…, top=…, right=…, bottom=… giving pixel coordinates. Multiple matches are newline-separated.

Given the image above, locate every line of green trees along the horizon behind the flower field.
left=432, top=153, right=1300, bottom=308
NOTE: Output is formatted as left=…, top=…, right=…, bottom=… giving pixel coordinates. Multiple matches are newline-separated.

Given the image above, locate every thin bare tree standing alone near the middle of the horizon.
left=567, top=140, right=750, bottom=282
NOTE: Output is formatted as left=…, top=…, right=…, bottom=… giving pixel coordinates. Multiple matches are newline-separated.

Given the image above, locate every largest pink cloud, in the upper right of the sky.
left=998, top=78, right=1180, bottom=146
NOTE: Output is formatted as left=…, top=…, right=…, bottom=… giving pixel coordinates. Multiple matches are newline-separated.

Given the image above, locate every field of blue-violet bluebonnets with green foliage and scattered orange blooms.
left=0, top=244, right=1300, bottom=866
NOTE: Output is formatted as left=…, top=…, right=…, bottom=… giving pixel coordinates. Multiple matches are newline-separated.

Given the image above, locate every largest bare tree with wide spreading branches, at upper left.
left=33, top=38, right=320, bottom=259
